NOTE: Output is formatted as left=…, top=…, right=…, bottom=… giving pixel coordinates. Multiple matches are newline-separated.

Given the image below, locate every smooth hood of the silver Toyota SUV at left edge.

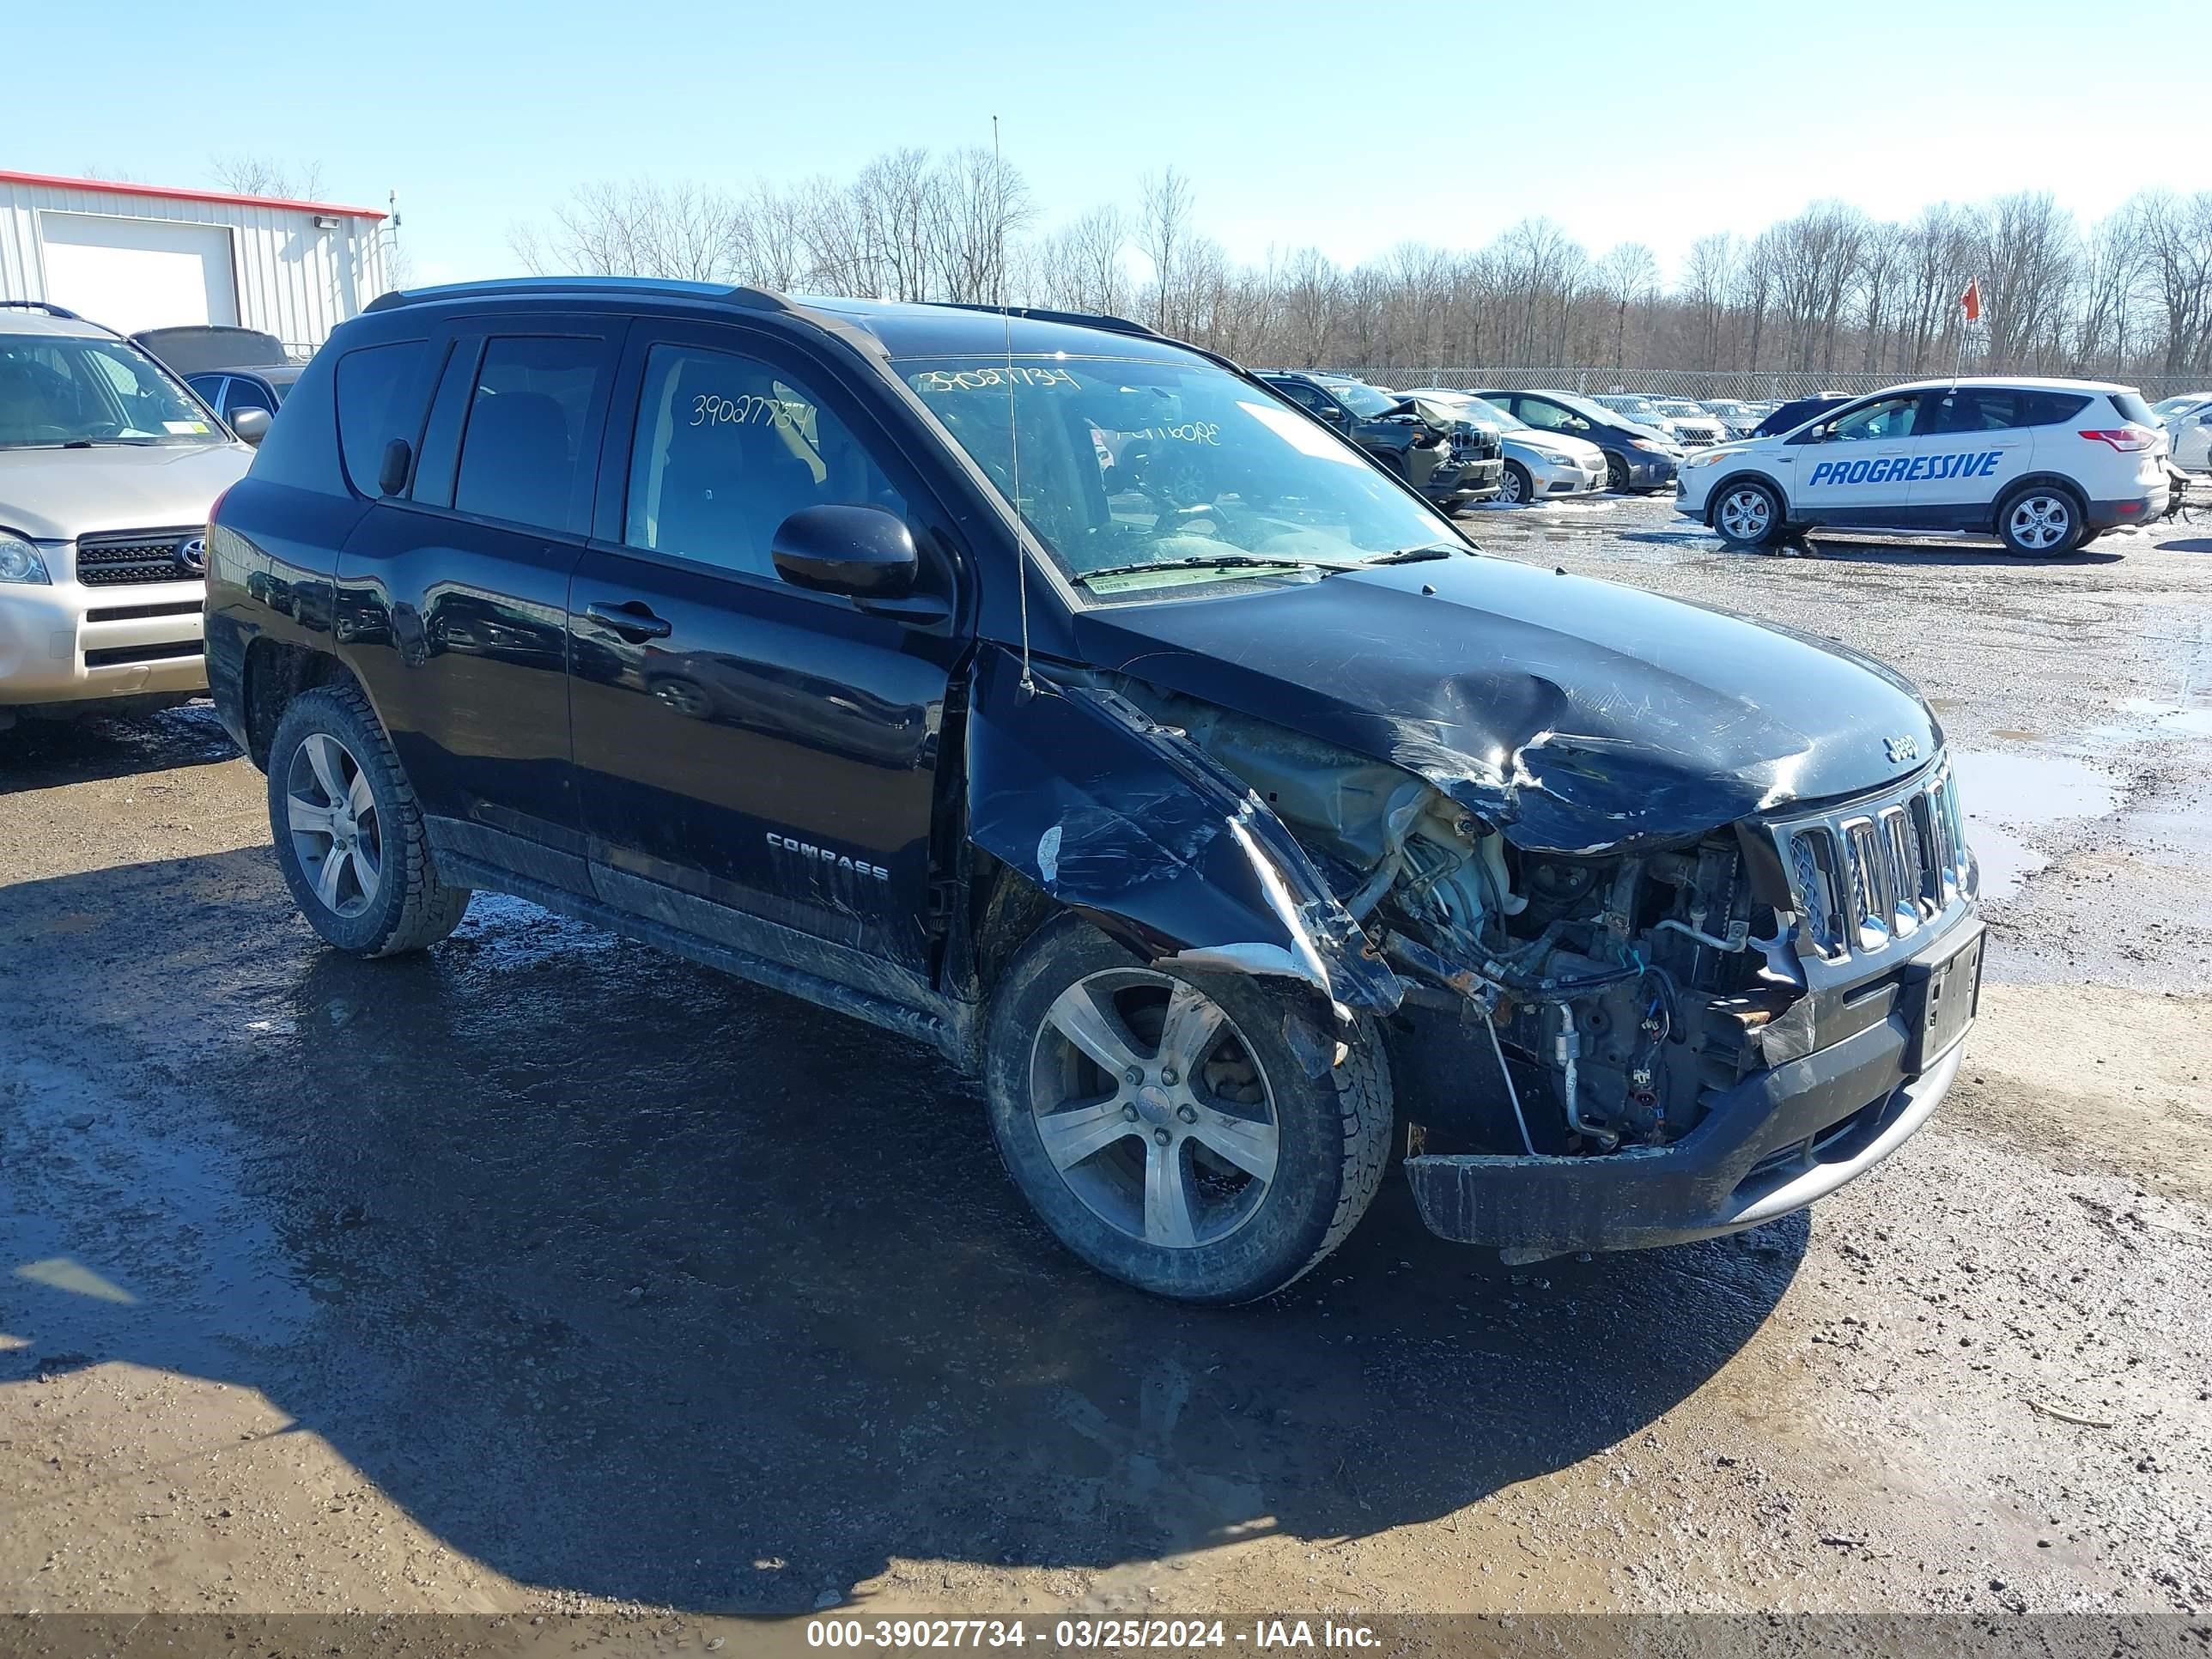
left=0, top=442, right=254, bottom=542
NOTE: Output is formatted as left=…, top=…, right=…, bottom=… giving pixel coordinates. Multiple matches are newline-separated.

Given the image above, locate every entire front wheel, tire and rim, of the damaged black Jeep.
left=984, top=915, right=1391, bottom=1303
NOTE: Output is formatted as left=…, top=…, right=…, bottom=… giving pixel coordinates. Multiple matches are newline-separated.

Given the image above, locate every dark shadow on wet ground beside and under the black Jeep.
left=0, top=849, right=1805, bottom=1613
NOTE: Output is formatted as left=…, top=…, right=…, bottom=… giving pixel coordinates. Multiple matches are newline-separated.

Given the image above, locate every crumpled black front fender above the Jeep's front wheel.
left=967, top=646, right=1402, bottom=1015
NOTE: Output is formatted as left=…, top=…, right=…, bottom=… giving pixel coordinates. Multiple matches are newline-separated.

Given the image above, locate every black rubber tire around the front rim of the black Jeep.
left=984, top=915, right=1347, bottom=1303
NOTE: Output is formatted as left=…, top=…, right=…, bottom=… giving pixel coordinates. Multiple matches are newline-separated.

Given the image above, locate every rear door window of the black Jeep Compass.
left=453, top=334, right=608, bottom=531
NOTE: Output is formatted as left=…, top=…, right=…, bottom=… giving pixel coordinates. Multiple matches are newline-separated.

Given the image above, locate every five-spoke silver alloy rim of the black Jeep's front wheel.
left=1029, top=969, right=1281, bottom=1249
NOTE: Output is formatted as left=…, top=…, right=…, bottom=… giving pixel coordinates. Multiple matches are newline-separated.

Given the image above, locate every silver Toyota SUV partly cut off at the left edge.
left=0, top=301, right=258, bottom=728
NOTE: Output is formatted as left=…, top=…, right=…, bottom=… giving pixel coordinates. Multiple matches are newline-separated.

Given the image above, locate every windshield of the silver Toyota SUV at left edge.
left=0, top=334, right=223, bottom=449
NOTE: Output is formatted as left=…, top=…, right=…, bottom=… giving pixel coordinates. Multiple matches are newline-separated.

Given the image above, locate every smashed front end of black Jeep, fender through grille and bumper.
left=971, top=664, right=1982, bottom=1261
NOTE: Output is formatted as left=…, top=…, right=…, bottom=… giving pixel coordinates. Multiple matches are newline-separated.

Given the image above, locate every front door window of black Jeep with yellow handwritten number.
left=622, top=345, right=907, bottom=577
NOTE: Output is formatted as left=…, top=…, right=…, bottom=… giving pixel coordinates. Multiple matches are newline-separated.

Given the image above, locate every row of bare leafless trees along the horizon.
left=511, top=149, right=2212, bottom=380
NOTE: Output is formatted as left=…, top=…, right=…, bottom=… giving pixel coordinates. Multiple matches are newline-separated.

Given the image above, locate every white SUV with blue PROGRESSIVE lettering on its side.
left=1679, top=378, right=2167, bottom=557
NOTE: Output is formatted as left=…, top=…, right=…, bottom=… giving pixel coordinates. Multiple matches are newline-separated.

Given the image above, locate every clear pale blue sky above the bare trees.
left=17, top=0, right=2212, bottom=279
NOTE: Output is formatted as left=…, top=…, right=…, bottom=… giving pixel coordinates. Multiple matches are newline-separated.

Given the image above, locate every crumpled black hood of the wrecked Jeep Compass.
left=1078, top=557, right=1942, bottom=854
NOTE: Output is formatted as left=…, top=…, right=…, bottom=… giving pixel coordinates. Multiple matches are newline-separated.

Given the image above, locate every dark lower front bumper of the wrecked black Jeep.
left=1405, top=921, right=1982, bottom=1261
